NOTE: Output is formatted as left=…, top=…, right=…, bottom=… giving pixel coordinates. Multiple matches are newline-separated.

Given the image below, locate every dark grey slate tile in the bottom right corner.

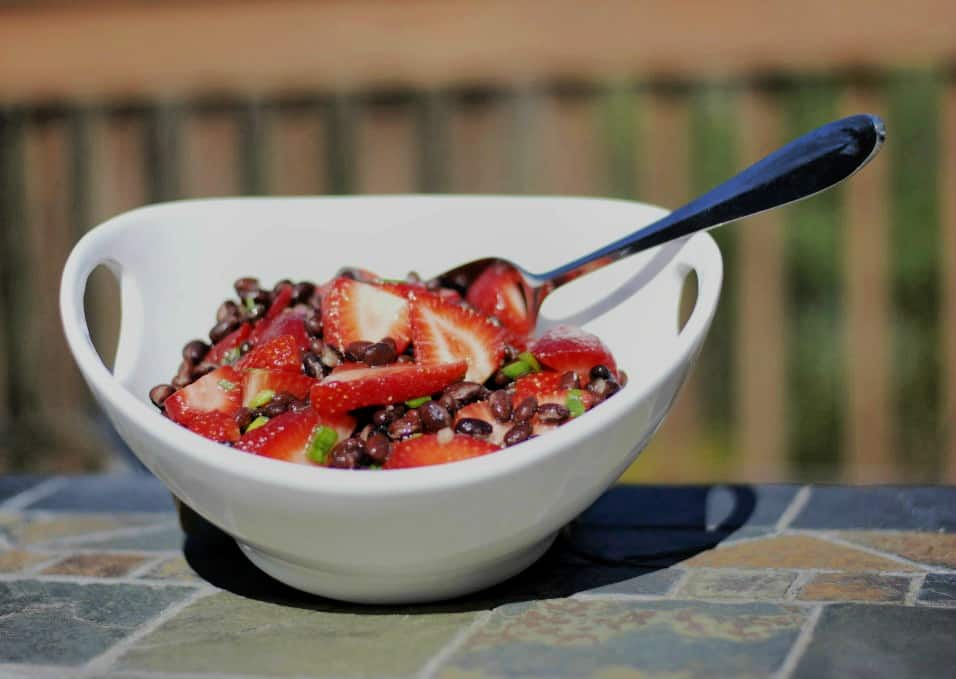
left=793, top=604, right=956, bottom=679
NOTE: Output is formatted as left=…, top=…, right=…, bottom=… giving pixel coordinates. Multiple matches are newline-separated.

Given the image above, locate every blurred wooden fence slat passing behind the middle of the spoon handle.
left=733, top=91, right=787, bottom=482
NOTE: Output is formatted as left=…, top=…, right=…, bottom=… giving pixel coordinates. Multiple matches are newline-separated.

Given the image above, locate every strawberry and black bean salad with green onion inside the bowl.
left=149, top=269, right=627, bottom=470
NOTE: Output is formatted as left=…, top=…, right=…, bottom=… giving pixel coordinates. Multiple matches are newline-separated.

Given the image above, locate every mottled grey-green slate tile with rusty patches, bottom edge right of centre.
left=438, top=599, right=806, bottom=678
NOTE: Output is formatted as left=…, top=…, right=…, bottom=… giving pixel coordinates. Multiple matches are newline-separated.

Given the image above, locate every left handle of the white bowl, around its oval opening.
left=60, top=225, right=144, bottom=386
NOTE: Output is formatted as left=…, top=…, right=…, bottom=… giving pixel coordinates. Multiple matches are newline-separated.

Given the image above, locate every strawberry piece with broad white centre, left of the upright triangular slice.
left=322, top=278, right=410, bottom=353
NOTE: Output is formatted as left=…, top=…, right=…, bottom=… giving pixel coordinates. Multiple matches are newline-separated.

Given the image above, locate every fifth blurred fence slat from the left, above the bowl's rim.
left=355, top=98, right=419, bottom=194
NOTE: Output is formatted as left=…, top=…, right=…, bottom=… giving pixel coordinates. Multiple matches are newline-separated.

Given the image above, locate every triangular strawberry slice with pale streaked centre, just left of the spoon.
left=410, top=296, right=505, bottom=383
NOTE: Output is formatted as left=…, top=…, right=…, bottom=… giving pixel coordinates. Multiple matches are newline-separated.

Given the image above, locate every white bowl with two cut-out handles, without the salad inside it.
left=60, top=196, right=722, bottom=603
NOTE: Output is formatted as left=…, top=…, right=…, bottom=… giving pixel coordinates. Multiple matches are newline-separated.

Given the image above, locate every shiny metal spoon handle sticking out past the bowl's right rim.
left=536, top=114, right=886, bottom=289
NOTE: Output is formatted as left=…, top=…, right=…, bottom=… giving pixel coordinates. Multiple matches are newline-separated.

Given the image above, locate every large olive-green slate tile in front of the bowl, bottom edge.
left=119, top=593, right=475, bottom=677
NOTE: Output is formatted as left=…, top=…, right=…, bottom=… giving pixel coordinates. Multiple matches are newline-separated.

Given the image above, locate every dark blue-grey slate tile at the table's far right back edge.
left=791, top=486, right=956, bottom=532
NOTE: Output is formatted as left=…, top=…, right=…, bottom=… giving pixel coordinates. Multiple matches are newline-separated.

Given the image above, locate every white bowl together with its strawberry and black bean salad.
left=60, top=196, right=722, bottom=603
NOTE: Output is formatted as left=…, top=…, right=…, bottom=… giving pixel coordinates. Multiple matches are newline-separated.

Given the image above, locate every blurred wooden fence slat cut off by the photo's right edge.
left=938, top=75, right=956, bottom=483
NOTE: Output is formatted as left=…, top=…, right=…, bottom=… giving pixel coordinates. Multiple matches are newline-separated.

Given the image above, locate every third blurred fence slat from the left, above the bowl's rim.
left=180, top=108, right=242, bottom=198
